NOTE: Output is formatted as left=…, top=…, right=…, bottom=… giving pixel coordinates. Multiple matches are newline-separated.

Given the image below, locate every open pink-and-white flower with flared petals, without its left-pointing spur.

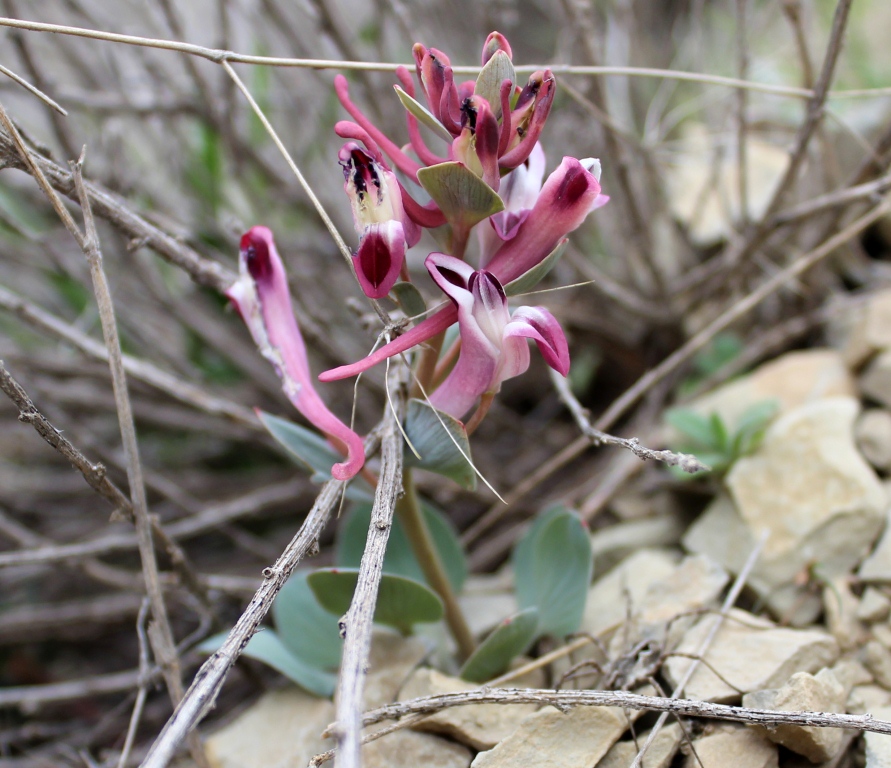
left=426, top=253, right=569, bottom=419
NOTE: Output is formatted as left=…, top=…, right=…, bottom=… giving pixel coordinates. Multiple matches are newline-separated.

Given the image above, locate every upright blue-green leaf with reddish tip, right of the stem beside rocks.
left=513, top=508, right=594, bottom=637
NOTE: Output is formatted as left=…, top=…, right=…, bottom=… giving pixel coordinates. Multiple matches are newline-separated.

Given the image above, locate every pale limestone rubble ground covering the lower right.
left=207, top=291, right=891, bottom=768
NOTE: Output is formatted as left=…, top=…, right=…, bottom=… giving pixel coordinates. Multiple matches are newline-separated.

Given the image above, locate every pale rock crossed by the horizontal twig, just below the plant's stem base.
left=399, top=669, right=536, bottom=749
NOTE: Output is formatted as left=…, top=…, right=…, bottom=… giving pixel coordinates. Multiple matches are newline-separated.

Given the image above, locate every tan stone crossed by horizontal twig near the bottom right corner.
left=743, top=669, right=847, bottom=763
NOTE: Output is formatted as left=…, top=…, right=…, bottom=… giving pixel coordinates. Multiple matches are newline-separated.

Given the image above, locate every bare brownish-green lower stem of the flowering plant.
left=396, top=469, right=476, bottom=661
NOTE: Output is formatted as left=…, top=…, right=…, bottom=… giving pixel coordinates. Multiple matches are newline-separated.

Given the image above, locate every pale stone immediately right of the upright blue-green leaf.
left=580, top=549, right=679, bottom=636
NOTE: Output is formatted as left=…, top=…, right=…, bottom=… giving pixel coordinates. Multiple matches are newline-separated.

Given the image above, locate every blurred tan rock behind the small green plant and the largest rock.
left=669, top=349, right=857, bottom=432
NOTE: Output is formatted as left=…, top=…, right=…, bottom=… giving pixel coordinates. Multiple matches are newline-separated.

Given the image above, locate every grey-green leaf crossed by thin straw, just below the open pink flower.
left=404, top=400, right=476, bottom=491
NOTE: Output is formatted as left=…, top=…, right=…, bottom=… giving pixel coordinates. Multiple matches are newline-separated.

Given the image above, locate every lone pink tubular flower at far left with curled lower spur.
left=226, top=227, right=365, bottom=480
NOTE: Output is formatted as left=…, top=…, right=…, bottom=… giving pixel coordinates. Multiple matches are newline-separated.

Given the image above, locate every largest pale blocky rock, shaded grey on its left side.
left=684, top=398, right=891, bottom=625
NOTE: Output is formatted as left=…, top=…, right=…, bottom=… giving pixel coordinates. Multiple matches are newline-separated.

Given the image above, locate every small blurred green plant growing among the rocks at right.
left=665, top=400, right=779, bottom=480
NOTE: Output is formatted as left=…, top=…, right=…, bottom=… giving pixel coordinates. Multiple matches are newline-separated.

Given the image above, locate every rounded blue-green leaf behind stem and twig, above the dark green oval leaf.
left=335, top=499, right=467, bottom=592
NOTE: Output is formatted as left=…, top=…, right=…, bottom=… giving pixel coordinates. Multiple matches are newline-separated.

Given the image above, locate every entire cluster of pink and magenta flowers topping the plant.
left=229, top=32, right=609, bottom=477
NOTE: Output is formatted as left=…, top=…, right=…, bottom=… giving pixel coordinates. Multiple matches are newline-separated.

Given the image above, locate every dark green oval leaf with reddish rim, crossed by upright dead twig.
left=308, top=568, right=443, bottom=635
